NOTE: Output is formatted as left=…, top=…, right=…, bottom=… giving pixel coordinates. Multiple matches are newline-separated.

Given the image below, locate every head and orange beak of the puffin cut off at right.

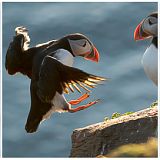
left=134, top=12, right=158, bottom=40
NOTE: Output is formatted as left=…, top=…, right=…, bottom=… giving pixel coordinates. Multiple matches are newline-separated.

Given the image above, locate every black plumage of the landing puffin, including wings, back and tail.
left=5, top=27, right=105, bottom=133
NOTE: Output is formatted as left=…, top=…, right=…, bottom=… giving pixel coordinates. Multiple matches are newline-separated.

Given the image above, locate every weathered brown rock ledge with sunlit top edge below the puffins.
left=70, top=107, right=158, bottom=157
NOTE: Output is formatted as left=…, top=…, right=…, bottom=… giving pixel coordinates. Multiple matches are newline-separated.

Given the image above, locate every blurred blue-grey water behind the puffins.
left=3, top=3, right=157, bottom=157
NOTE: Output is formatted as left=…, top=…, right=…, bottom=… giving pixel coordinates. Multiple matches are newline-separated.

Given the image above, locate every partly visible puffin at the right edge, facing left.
left=134, top=12, right=158, bottom=85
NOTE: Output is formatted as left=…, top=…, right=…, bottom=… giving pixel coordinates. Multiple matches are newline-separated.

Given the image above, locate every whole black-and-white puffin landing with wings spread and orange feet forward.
left=5, top=26, right=106, bottom=133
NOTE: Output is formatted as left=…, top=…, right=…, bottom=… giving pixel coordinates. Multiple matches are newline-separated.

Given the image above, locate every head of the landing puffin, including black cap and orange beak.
left=60, top=33, right=99, bottom=62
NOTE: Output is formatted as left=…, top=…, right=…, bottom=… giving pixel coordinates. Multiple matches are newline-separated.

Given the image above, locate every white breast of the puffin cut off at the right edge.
left=142, top=44, right=158, bottom=85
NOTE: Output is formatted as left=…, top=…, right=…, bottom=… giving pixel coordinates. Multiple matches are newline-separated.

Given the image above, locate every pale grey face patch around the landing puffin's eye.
left=68, top=39, right=92, bottom=56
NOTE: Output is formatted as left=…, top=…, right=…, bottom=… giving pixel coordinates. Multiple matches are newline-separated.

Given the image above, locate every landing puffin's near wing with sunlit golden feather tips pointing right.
left=37, top=56, right=106, bottom=102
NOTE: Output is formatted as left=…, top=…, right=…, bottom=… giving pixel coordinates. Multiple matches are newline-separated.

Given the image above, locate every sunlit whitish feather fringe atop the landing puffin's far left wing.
left=15, top=26, right=30, bottom=50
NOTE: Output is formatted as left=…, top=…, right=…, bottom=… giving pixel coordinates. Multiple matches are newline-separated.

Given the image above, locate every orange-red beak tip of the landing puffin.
left=85, top=47, right=99, bottom=62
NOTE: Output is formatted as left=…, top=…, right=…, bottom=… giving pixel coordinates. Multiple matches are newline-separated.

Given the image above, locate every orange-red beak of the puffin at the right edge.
left=134, top=20, right=150, bottom=41
